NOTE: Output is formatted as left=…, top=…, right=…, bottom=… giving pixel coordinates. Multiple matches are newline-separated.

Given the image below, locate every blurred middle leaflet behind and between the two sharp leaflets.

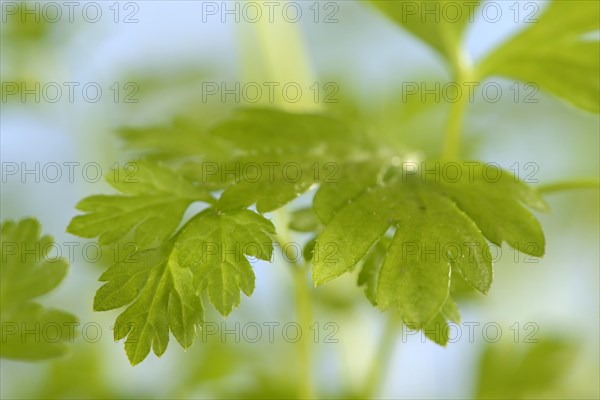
left=179, top=109, right=368, bottom=212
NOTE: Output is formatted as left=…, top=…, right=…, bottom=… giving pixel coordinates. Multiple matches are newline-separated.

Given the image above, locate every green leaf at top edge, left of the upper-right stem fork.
left=369, top=0, right=480, bottom=67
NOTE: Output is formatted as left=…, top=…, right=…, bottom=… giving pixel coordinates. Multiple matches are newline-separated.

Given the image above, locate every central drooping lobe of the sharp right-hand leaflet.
left=377, top=188, right=492, bottom=323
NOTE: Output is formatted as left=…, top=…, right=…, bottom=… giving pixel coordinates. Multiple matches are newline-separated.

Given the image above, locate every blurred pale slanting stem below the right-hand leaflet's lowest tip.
left=358, top=311, right=401, bottom=399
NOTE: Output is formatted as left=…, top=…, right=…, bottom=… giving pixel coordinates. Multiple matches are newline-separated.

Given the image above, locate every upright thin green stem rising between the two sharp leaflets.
left=278, top=209, right=314, bottom=399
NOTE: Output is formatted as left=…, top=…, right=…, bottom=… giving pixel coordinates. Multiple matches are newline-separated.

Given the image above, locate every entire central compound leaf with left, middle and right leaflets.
left=69, top=109, right=546, bottom=356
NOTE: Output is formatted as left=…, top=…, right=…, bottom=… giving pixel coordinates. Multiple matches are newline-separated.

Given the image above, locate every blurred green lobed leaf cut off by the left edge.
left=0, top=218, right=77, bottom=361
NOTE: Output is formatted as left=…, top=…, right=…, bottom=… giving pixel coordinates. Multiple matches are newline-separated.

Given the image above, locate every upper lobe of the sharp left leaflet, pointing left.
left=67, top=162, right=214, bottom=249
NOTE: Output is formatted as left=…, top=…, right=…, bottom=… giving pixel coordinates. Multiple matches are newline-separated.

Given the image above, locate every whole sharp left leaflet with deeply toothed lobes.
left=68, top=152, right=275, bottom=365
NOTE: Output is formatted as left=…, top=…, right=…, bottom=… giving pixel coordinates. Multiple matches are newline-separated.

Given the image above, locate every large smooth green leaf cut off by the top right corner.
left=478, top=0, right=600, bottom=113
